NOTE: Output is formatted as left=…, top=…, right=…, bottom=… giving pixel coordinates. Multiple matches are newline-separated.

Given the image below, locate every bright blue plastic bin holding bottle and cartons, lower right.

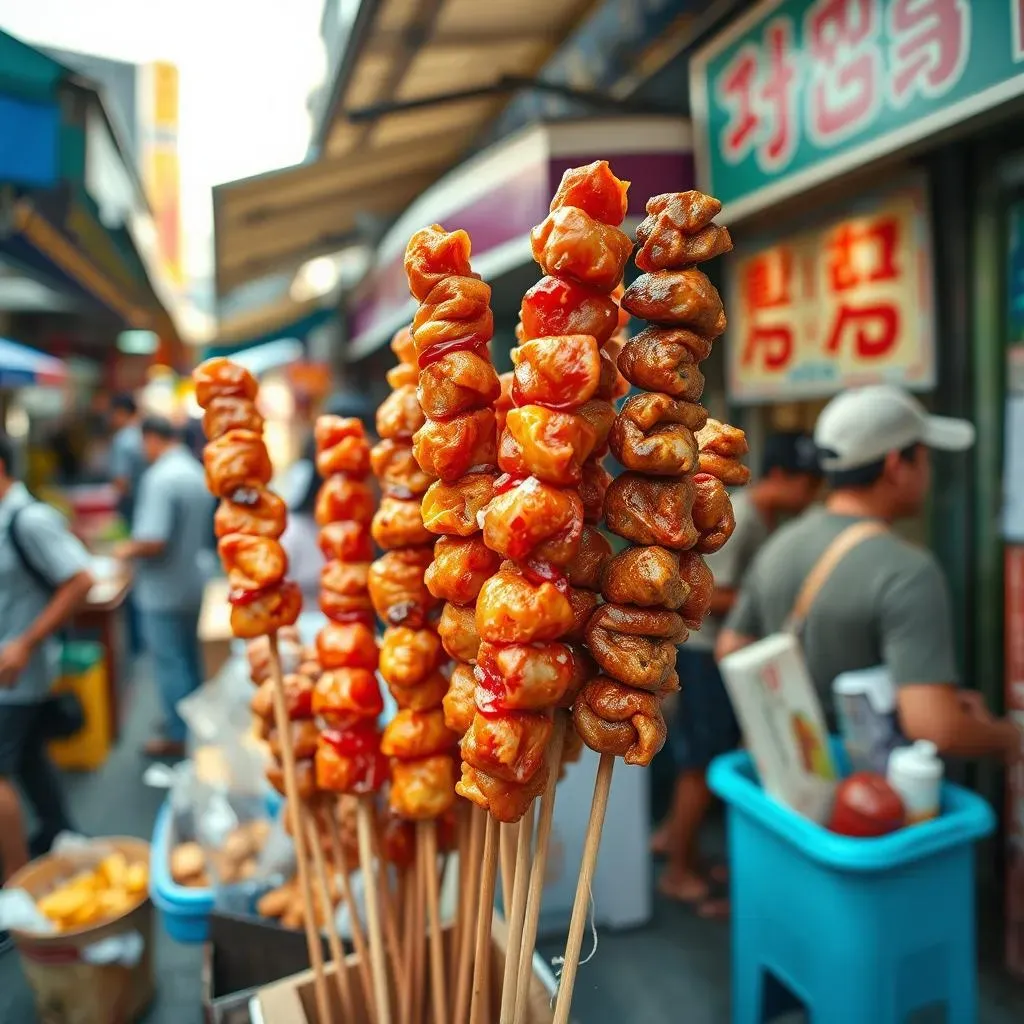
left=709, top=752, right=995, bottom=1024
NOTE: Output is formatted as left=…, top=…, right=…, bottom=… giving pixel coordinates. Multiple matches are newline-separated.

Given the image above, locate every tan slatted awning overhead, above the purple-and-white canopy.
left=213, top=0, right=595, bottom=295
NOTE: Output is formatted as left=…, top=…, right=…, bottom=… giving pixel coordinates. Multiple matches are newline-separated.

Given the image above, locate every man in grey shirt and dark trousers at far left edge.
left=0, top=434, right=92, bottom=879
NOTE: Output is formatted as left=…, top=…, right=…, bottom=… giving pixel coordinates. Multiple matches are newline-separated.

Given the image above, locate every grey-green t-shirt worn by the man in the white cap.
left=725, top=508, right=957, bottom=722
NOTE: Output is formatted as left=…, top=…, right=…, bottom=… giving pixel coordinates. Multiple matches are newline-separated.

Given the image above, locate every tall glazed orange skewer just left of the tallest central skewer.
left=406, top=224, right=501, bottom=1024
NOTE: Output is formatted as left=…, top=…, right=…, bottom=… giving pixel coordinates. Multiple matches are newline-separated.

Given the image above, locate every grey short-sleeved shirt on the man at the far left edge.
left=0, top=483, right=89, bottom=706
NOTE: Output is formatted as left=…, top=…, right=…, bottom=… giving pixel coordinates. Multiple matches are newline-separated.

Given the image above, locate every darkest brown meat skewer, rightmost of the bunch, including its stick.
left=554, top=191, right=749, bottom=1024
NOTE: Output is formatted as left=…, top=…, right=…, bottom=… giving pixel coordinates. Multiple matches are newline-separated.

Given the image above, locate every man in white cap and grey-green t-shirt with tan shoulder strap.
left=716, top=385, right=1022, bottom=760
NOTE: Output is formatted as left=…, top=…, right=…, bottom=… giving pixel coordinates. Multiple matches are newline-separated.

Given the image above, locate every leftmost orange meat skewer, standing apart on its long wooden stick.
left=193, top=358, right=331, bottom=1021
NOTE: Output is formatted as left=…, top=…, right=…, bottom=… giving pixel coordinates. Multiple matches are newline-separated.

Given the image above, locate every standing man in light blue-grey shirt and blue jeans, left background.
left=117, top=416, right=213, bottom=758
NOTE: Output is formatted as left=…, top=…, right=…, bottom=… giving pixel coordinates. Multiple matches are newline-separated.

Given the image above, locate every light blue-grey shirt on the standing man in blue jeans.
left=132, top=444, right=213, bottom=611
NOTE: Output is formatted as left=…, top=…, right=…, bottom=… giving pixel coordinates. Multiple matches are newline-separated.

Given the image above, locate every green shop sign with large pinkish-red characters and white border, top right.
left=690, top=0, right=1024, bottom=219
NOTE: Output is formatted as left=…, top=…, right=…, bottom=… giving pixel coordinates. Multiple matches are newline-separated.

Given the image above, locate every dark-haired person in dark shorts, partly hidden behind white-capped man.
left=651, top=432, right=821, bottom=915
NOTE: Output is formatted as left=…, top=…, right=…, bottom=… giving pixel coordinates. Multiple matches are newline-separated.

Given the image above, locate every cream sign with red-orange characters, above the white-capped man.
left=726, top=184, right=935, bottom=401
